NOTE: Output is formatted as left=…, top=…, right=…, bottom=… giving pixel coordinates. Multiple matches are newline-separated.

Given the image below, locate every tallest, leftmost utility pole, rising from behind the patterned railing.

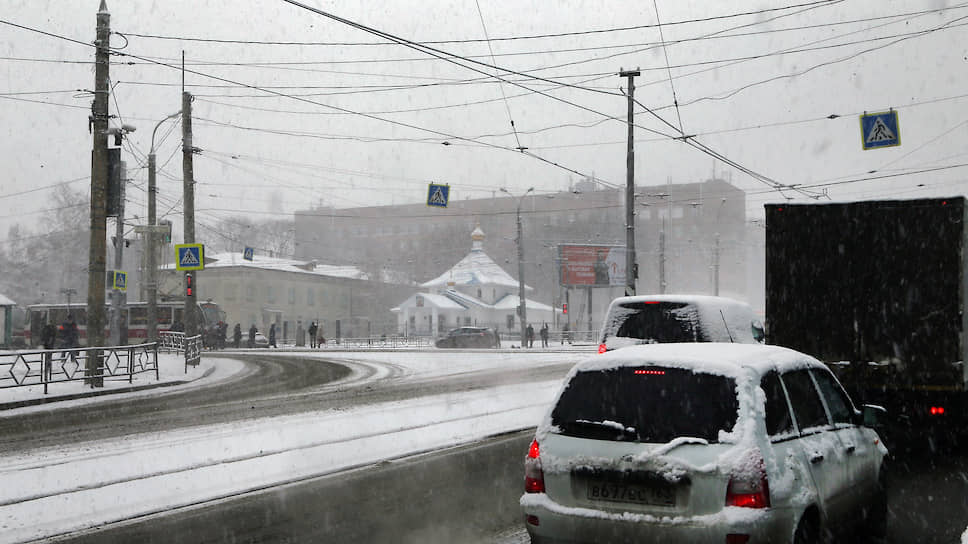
left=85, top=0, right=111, bottom=387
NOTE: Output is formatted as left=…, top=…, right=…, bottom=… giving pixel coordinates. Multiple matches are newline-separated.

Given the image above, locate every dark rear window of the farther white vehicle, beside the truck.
left=602, top=302, right=700, bottom=344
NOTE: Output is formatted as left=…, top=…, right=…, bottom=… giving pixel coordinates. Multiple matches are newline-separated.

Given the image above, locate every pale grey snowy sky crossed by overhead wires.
left=0, top=0, right=968, bottom=243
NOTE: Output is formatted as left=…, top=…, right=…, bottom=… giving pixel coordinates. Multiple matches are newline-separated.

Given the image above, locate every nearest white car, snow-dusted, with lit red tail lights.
left=520, top=343, right=887, bottom=544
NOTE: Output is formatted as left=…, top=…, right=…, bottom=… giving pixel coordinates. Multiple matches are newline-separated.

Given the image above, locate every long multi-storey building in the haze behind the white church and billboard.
left=295, top=179, right=749, bottom=330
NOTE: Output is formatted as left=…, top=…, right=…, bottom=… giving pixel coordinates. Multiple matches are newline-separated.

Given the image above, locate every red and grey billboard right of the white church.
left=558, top=244, right=625, bottom=287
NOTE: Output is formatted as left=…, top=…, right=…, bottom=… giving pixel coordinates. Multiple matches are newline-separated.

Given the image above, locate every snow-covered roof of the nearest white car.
left=572, top=342, right=824, bottom=376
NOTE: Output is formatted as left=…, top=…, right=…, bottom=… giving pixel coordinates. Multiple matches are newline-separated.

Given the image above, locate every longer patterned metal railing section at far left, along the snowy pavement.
left=0, top=343, right=159, bottom=395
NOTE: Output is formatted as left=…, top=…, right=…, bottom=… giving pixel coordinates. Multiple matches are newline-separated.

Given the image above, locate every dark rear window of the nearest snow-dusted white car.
left=551, top=366, right=739, bottom=443
